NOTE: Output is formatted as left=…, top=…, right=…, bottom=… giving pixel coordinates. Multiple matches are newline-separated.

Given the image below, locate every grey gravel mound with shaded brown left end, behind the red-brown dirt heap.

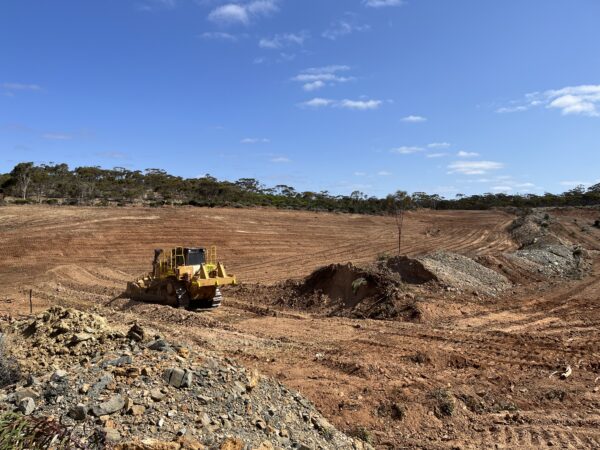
left=386, top=252, right=511, bottom=296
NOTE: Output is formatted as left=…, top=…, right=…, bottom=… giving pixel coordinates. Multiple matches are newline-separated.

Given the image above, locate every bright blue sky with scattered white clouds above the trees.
left=0, top=0, right=600, bottom=197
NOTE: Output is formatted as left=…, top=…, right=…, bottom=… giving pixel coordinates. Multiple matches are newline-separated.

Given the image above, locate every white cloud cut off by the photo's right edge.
left=496, top=84, right=600, bottom=117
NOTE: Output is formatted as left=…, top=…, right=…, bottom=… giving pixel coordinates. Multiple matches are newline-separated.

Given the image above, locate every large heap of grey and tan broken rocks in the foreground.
left=0, top=307, right=369, bottom=450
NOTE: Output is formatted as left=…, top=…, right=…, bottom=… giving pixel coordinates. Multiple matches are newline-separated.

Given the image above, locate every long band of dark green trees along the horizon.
left=0, top=162, right=600, bottom=214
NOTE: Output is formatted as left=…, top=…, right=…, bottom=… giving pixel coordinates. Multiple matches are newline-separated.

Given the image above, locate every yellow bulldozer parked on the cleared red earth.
left=125, top=246, right=237, bottom=309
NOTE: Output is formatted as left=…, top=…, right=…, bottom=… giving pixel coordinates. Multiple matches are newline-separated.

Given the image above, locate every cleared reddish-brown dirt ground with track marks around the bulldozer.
left=0, top=206, right=600, bottom=449
